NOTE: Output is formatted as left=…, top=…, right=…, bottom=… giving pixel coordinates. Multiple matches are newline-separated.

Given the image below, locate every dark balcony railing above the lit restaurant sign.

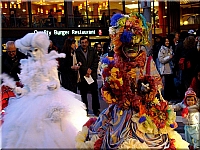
left=1, top=14, right=110, bottom=28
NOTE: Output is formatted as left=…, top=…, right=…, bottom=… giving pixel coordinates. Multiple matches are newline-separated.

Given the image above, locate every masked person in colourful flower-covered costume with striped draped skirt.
left=76, top=13, right=188, bottom=149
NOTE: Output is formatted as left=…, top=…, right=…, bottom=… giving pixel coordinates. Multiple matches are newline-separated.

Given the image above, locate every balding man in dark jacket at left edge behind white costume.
left=2, top=41, right=27, bottom=81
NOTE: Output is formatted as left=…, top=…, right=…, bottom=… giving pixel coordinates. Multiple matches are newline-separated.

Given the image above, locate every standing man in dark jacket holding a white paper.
left=76, top=36, right=100, bottom=116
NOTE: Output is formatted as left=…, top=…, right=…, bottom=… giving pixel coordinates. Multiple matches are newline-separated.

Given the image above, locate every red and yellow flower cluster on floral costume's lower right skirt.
left=132, top=101, right=177, bottom=134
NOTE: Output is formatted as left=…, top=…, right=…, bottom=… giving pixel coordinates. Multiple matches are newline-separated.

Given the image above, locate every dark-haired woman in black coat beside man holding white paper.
left=59, top=39, right=80, bottom=93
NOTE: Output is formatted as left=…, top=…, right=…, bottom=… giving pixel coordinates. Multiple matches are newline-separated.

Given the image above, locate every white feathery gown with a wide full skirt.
left=1, top=54, right=88, bottom=149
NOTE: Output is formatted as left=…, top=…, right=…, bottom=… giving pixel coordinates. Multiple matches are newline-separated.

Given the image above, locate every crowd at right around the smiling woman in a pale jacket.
left=151, top=29, right=200, bottom=103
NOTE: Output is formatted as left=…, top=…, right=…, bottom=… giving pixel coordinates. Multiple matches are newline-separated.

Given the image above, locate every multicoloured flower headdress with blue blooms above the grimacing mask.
left=109, top=13, right=151, bottom=53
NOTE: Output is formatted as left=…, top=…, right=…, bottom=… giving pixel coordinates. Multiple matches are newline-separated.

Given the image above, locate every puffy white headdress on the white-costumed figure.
left=15, top=32, right=50, bottom=54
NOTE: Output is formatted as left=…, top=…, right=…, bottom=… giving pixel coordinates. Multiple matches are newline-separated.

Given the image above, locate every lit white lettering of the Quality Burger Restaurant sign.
left=34, top=29, right=96, bottom=36
